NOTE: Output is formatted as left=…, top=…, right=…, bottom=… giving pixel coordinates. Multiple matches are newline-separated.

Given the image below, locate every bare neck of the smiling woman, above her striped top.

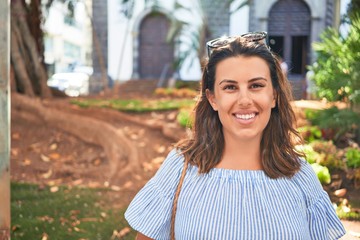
left=216, top=135, right=263, bottom=170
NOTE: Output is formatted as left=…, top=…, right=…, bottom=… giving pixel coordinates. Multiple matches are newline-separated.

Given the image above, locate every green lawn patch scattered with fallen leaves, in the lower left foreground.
left=11, top=183, right=135, bottom=240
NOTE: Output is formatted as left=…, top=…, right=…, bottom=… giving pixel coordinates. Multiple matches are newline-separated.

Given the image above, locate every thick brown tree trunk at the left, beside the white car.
left=10, top=0, right=51, bottom=97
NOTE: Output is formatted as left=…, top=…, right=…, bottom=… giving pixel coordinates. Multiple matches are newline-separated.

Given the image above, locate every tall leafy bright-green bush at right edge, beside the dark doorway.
left=309, top=14, right=360, bottom=104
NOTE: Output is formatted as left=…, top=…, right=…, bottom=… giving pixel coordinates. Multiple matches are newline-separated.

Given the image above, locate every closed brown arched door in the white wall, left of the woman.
left=138, top=12, right=174, bottom=79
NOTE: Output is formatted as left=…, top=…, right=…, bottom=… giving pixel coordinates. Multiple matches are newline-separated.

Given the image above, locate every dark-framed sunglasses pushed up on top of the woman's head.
left=206, top=32, right=269, bottom=57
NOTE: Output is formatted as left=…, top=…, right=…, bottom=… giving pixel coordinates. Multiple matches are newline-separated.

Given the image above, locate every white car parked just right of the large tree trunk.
left=47, top=72, right=90, bottom=97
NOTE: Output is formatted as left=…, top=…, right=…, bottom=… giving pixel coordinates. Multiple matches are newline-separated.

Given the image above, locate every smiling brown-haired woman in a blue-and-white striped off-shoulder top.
left=125, top=32, right=345, bottom=240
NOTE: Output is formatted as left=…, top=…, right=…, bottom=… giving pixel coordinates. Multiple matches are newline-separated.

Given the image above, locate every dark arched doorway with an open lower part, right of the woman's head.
left=268, top=0, right=311, bottom=76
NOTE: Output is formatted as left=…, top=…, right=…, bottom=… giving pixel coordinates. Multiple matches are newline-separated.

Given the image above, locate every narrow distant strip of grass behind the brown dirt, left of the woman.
left=71, top=99, right=194, bottom=112
